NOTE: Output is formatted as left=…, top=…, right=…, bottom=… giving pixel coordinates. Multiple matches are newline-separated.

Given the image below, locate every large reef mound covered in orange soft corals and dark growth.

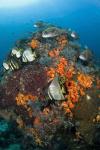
left=0, top=21, right=100, bottom=150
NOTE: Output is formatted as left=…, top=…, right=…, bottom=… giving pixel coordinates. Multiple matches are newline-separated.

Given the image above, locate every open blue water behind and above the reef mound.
left=0, top=0, right=100, bottom=62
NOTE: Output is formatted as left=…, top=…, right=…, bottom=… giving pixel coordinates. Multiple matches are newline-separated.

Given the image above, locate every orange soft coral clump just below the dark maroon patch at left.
left=16, top=93, right=37, bottom=108
